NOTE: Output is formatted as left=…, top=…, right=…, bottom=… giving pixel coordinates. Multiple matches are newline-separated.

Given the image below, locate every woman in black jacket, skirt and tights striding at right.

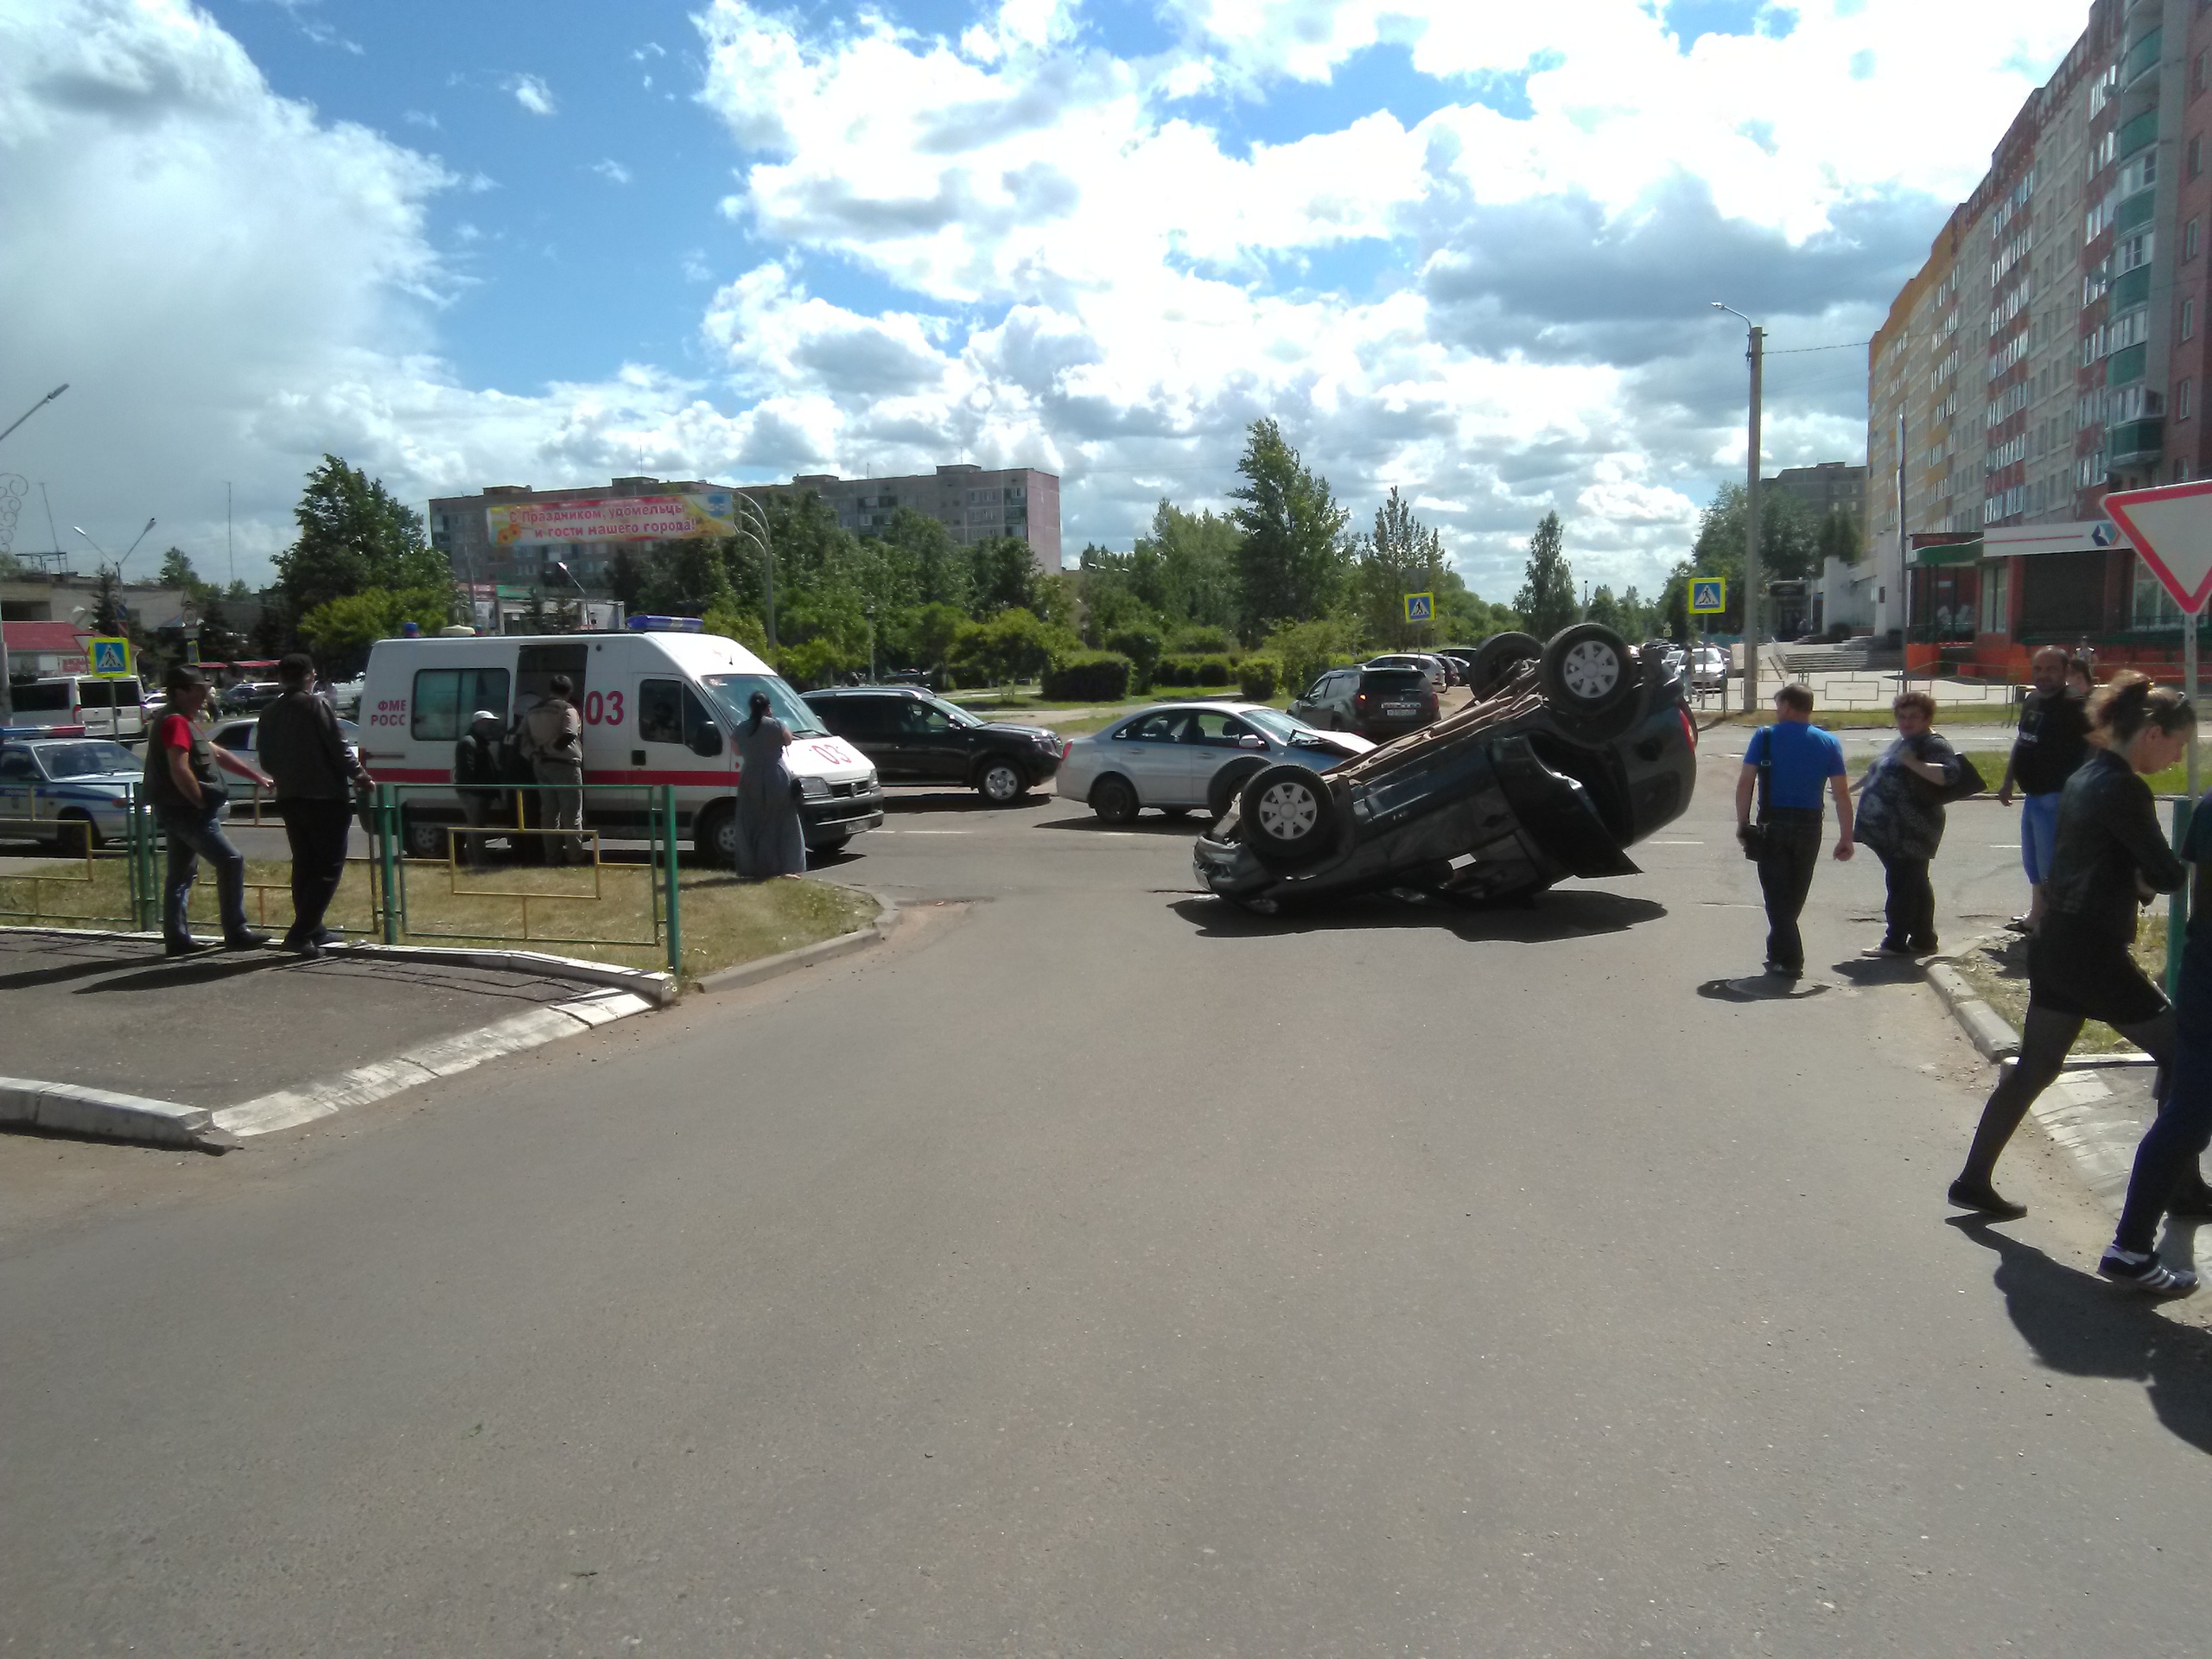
left=1951, top=671, right=2212, bottom=1265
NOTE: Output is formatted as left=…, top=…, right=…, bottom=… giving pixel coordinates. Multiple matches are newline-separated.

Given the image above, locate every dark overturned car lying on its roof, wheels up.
left=1192, top=621, right=1697, bottom=912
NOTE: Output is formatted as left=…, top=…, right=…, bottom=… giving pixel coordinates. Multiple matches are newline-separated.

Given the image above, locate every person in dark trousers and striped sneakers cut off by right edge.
left=2099, top=779, right=2212, bottom=1294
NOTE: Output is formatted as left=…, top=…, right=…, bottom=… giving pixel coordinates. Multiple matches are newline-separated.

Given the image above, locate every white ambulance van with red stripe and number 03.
left=359, top=617, right=882, bottom=865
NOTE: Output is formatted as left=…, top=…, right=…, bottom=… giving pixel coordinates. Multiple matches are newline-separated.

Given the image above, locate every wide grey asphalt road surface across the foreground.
left=0, top=757, right=2212, bottom=1655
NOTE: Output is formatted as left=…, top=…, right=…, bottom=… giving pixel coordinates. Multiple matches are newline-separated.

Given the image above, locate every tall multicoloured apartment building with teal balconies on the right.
left=1865, top=0, right=2212, bottom=672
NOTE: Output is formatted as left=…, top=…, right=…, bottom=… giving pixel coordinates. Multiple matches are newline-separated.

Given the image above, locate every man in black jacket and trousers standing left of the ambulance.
left=254, top=651, right=370, bottom=957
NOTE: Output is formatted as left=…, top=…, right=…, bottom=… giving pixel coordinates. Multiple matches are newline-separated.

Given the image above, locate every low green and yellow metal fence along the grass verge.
left=0, top=783, right=683, bottom=971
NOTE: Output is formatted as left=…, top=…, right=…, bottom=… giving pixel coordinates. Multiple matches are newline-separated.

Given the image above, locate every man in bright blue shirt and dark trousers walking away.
left=1737, top=686, right=1852, bottom=980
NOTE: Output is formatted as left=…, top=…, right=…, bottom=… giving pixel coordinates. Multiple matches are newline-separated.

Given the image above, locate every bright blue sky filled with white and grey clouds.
left=0, top=0, right=2084, bottom=597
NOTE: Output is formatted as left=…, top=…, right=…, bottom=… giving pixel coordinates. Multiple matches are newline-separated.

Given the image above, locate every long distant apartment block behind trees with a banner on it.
left=429, top=465, right=1059, bottom=588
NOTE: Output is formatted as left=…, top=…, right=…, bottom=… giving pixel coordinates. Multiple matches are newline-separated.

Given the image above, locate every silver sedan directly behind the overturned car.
left=1059, top=702, right=1374, bottom=823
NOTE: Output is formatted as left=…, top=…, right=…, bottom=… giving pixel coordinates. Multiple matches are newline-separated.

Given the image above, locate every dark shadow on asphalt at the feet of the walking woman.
left=1951, top=1219, right=2212, bottom=1451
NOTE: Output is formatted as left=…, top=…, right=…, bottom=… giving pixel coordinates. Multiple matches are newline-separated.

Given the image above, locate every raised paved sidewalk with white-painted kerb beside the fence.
left=0, top=931, right=606, bottom=1110
